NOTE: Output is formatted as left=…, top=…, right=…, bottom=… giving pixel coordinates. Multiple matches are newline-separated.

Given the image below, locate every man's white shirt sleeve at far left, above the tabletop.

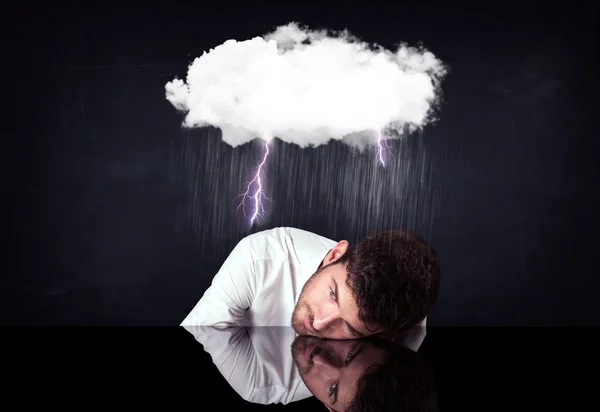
left=181, top=239, right=256, bottom=327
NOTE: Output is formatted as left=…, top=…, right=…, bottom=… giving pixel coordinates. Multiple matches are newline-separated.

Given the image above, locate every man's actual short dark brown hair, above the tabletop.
left=336, top=230, right=440, bottom=332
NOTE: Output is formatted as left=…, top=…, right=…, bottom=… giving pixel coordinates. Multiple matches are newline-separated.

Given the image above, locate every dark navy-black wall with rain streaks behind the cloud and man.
left=1, top=1, right=600, bottom=325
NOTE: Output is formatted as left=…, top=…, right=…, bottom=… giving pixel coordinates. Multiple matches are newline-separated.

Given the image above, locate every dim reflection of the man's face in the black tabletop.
left=292, top=336, right=383, bottom=411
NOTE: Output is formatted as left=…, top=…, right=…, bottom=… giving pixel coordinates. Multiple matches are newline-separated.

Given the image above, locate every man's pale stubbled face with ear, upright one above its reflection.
left=292, top=240, right=374, bottom=339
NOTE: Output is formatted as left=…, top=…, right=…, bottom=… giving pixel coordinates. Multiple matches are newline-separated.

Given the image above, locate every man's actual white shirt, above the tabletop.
left=181, top=227, right=427, bottom=340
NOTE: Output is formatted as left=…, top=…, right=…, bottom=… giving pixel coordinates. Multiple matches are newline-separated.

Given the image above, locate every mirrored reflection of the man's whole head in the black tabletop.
left=292, top=336, right=437, bottom=412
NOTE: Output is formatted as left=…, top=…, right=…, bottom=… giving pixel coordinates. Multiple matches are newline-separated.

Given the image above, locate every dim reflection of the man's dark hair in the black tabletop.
left=346, top=341, right=437, bottom=412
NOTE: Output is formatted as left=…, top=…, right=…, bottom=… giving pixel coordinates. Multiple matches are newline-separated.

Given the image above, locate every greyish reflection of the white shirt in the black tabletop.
left=185, top=326, right=312, bottom=405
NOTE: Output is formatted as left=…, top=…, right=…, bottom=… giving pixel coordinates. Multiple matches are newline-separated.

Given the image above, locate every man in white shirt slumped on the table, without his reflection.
left=181, top=227, right=440, bottom=339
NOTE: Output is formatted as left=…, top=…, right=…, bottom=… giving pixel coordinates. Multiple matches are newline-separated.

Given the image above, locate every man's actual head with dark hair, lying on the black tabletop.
left=292, top=230, right=440, bottom=339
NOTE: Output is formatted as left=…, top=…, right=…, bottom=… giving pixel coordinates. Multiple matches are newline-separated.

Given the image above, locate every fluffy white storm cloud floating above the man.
left=165, top=23, right=447, bottom=147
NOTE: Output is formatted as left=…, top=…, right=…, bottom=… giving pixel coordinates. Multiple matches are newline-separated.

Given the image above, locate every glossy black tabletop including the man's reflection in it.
left=1, top=327, right=584, bottom=411
